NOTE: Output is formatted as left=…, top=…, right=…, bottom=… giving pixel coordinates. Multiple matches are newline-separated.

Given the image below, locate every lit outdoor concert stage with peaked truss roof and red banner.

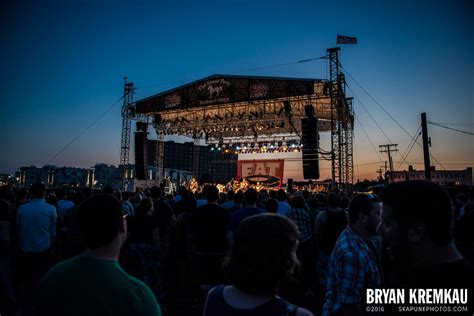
left=131, top=56, right=353, bottom=190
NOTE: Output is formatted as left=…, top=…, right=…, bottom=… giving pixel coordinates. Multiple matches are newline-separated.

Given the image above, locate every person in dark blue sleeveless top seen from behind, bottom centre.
left=204, top=214, right=312, bottom=316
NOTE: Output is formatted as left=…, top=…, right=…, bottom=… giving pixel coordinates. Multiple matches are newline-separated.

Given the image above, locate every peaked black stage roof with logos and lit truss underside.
left=134, top=74, right=348, bottom=139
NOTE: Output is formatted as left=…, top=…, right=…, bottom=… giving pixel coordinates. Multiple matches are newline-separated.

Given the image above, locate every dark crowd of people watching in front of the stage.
left=0, top=181, right=474, bottom=316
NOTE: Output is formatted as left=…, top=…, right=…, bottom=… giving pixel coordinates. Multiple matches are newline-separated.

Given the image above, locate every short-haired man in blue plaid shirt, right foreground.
left=322, top=194, right=382, bottom=316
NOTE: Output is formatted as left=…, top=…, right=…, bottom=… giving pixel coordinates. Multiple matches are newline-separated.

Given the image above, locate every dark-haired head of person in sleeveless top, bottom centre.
left=225, top=214, right=298, bottom=294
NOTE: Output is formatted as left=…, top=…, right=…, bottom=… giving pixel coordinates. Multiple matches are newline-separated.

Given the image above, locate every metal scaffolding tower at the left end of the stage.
left=120, top=77, right=134, bottom=165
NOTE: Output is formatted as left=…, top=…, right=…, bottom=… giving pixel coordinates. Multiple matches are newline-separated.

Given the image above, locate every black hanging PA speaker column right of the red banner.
left=301, top=117, right=319, bottom=179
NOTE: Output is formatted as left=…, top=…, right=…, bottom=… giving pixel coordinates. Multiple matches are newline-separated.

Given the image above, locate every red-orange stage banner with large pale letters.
left=237, top=159, right=285, bottom=181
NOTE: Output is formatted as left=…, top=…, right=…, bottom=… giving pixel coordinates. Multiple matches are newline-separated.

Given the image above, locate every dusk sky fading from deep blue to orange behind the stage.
left=0, top=0, right=474, bottom=179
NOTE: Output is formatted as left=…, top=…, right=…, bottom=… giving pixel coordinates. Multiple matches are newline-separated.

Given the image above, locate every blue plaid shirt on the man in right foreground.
left=322, top=225, right=382, bottom=316
